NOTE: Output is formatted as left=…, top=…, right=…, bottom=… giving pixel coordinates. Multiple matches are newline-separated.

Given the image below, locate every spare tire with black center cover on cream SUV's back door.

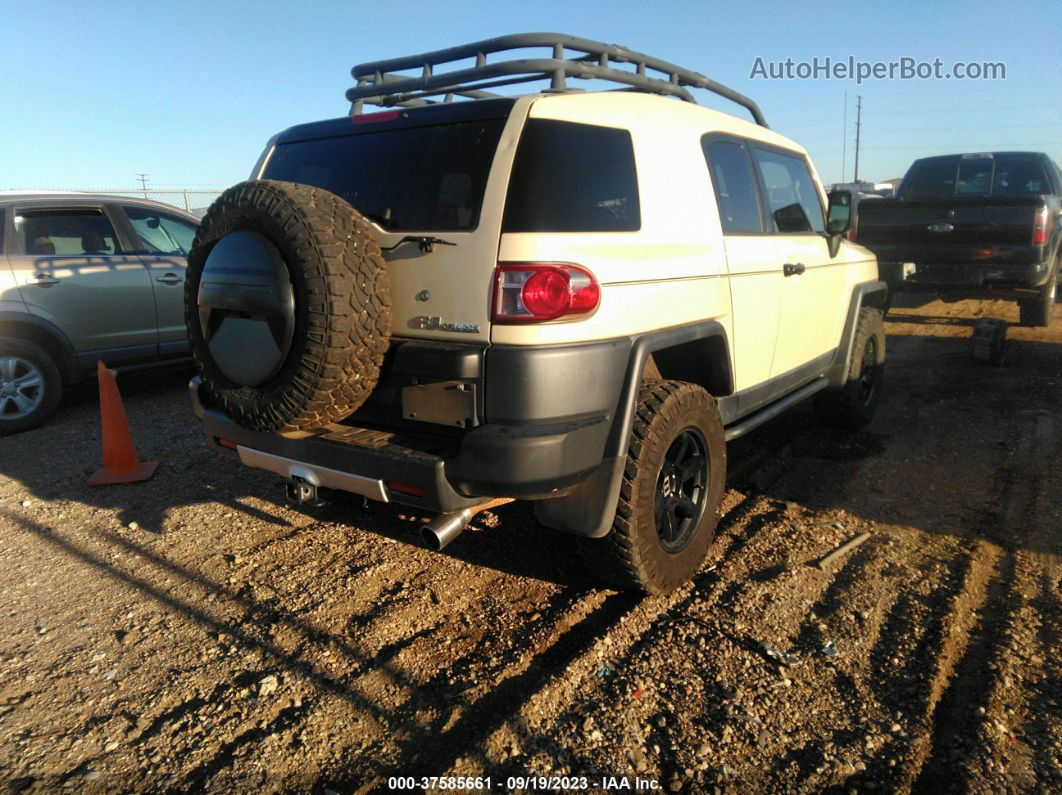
left=185, top=179, right=391, bottom=432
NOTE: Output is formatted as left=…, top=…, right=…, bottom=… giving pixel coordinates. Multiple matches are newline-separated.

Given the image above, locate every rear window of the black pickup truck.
left=900, top=155, right=1051, bottom=198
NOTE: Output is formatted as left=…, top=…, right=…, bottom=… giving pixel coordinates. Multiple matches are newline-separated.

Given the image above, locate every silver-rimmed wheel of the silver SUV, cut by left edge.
left=0, top=336, right=63, bottom=435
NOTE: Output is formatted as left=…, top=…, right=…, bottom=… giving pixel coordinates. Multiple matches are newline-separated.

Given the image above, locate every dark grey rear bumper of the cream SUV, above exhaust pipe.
left=189, top=377, right=611, bottom=512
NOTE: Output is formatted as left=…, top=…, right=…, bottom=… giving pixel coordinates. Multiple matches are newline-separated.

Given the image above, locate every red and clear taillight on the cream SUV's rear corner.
left=492, top=262, right=601, bottom=323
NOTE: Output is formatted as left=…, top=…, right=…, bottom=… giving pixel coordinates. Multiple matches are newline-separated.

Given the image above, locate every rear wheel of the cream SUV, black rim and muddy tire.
left=580, top=381, right=726, bottom=593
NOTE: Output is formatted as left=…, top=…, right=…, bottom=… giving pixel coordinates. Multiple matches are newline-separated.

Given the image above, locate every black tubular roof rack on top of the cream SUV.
left=346, top=33, right=767, bottom=127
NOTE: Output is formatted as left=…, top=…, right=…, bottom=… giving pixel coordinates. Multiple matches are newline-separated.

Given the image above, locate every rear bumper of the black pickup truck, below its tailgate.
left=877, top=261, right=1050, bottom=292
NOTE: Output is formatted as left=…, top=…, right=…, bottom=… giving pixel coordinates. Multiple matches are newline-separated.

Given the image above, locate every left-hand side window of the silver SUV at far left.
left=15, top=208, right=121, bottom=257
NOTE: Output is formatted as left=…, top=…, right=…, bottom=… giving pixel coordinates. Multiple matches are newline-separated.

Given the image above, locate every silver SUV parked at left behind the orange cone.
left=0, top=192, right=198, bottom=434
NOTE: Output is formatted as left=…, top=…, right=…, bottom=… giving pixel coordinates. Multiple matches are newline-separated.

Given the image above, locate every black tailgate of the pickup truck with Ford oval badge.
left=857, top=196, right=1044, bottom=264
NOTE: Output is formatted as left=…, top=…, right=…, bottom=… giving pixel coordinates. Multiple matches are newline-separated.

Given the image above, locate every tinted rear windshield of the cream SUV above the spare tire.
left=263, top=119, right=506, bottom=231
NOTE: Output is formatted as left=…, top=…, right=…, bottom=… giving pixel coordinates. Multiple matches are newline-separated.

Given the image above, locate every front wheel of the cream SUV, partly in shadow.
left=813, top=307, right=885, bottom=431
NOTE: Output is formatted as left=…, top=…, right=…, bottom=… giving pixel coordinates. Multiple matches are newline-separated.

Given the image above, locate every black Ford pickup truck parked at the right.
left=857, top=152, right=1062, bottom=326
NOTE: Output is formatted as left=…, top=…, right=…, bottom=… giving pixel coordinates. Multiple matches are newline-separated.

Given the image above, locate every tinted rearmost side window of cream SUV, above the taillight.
left=502, top=119, right=641, bottom=231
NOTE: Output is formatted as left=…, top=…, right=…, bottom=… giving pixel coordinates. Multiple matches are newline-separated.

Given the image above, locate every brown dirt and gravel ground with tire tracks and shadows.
left=0, top=300, right=1062, bottom=793
